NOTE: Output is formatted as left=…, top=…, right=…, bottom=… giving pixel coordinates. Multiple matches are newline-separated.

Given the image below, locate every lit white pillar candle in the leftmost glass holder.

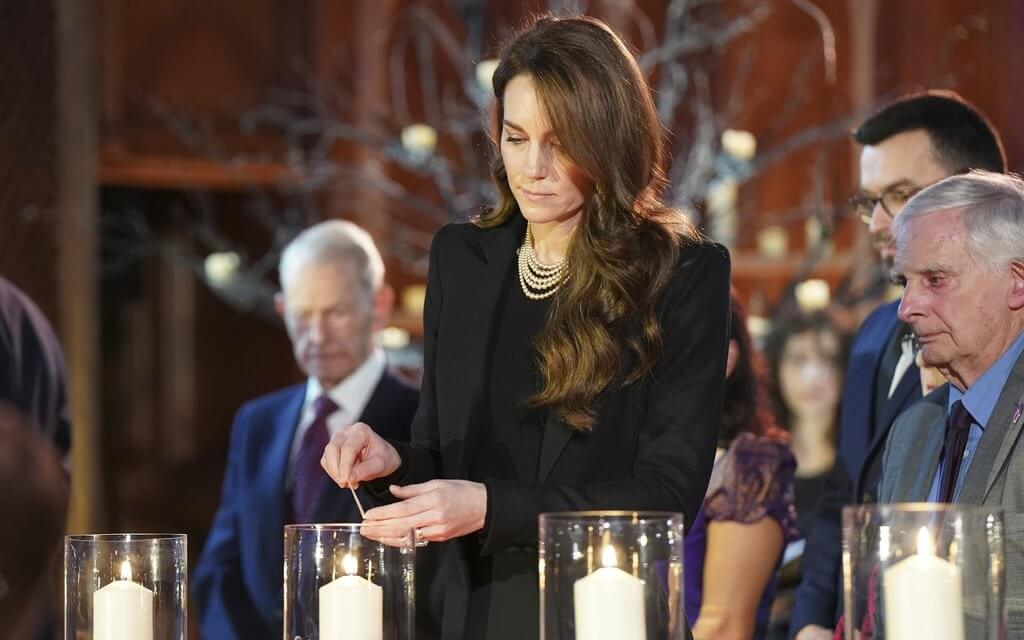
left=92, top=560, right=153, bottom=640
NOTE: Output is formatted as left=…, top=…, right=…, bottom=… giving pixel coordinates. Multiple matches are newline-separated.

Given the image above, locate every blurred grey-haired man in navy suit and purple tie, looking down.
left=193, top=220, right=419, bottom=640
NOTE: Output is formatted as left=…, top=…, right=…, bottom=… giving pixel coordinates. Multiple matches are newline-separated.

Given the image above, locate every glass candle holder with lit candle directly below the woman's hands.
left=285, top=524, right=416, bottom=640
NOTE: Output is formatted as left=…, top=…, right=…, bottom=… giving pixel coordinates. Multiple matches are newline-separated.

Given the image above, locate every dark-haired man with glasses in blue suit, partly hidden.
left=790, top=91, right=1006, bottom=640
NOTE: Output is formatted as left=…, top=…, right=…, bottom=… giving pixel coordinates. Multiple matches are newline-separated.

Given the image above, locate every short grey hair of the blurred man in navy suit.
left=278, top=220, right=384, bottom=294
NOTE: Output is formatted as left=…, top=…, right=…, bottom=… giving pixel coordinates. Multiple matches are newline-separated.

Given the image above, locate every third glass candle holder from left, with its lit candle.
left=539, top=511, right=686, bottom=640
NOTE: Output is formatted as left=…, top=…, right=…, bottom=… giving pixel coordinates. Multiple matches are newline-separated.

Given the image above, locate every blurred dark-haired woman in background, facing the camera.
left=765, top=311, right=846, bottom=538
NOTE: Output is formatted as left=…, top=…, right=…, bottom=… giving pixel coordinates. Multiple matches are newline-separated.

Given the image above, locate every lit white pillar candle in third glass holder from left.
left=572, top=546, right=647, bottom=640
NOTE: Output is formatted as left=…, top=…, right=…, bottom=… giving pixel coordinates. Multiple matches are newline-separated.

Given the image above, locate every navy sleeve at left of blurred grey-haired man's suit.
left=193, top=407, right=281, bottom=640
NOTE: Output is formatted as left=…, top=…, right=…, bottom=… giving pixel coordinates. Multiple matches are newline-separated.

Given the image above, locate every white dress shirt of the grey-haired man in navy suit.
left=286, top=349, right=387, bottom=488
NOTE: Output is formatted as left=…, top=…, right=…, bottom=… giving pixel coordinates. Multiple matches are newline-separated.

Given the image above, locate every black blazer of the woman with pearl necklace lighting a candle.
left=372, top=215, right=729, bottom=640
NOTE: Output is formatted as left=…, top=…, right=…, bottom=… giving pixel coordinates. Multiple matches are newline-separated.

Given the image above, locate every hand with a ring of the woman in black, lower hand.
left=364, top=480, right=487, bottom=543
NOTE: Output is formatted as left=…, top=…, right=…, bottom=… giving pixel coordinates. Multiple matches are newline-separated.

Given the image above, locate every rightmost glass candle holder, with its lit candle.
left=843, top=503, right=1006, bottom=640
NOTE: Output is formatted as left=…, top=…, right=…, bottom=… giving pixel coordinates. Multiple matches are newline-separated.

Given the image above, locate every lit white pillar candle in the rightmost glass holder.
left=884, top=527, right=964, bottom=640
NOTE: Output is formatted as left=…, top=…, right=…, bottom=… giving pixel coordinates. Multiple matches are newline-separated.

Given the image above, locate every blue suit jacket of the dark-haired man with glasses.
left=790, top=301, right=921, bottom=634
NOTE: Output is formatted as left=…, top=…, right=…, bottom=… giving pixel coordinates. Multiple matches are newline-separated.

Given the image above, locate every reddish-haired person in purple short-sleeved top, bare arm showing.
left=684, top=295, right=796, bottom=640
